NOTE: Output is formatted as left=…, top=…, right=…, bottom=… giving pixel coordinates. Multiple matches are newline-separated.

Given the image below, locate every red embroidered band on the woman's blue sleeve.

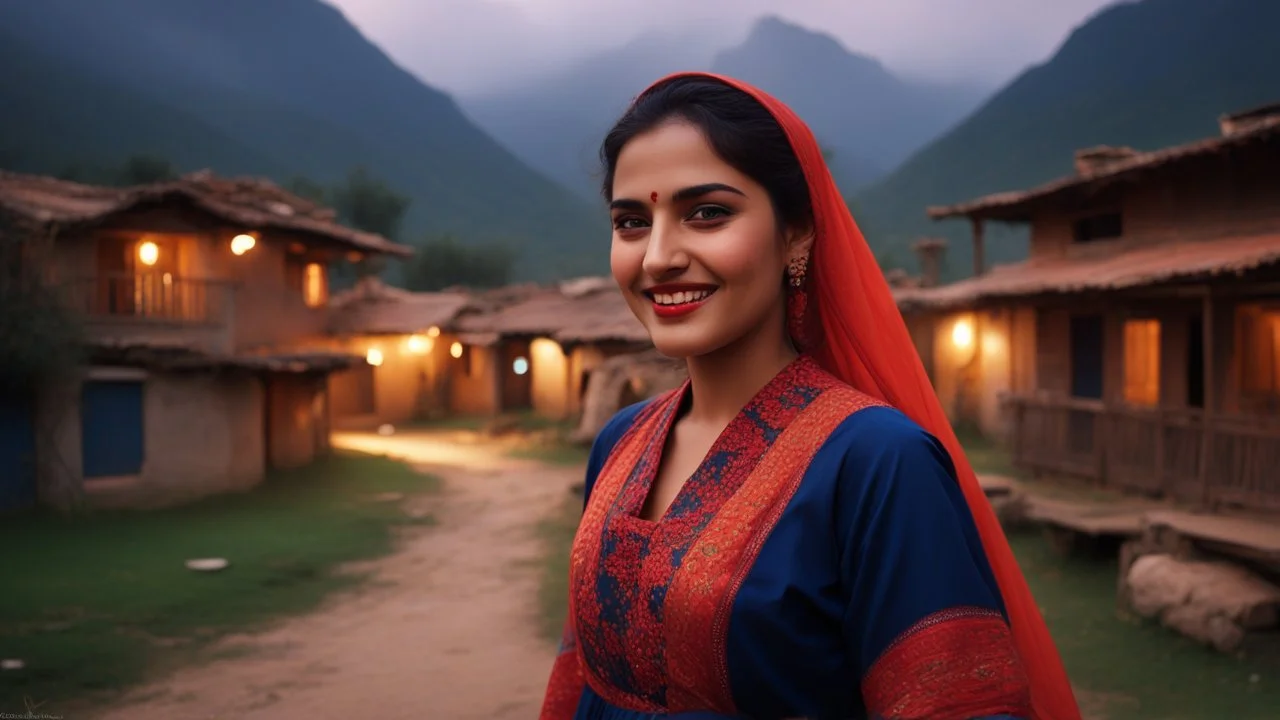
left=863, top=607, right=1030, bottom=720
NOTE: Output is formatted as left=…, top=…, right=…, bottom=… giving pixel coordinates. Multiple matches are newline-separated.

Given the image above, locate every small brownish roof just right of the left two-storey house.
left=329, top=278, right=472, bottom=334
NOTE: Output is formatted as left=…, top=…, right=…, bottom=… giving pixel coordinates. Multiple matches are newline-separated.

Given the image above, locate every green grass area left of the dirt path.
left=0, top=454, right=438, bottom=711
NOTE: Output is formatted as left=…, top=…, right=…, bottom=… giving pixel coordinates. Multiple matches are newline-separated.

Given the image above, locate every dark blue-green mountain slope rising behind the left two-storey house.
left=0, top=0, right=608, bottom=278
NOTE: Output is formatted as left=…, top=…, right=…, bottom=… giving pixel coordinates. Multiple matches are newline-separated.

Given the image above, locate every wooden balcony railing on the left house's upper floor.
left=67, top=273, right=233, bottom=325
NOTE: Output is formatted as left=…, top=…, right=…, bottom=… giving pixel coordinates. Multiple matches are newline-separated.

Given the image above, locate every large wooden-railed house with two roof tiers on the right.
left=895, top=106, right=1280, bottom=510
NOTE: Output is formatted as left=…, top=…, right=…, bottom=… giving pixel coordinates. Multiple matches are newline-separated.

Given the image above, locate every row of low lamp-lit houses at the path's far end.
left=325, top=271, right=650, bottom=429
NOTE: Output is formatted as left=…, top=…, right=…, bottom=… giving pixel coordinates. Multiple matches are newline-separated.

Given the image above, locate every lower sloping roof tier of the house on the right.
left=893, top=229, right=1280, bottom=311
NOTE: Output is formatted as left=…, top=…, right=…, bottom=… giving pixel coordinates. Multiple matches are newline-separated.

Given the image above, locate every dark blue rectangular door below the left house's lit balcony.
left=81, top=380, right=142, bottom=478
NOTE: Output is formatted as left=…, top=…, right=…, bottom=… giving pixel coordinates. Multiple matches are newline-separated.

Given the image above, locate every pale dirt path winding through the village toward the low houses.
left=92, top=434, right=579, bottom=720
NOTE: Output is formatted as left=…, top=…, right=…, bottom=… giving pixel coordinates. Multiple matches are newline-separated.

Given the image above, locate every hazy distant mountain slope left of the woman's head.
left=460, top=33, right=714, bottom=200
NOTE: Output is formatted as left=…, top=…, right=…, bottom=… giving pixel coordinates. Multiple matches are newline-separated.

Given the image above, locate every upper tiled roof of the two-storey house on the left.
left=0, top=170, right=413, bottom=256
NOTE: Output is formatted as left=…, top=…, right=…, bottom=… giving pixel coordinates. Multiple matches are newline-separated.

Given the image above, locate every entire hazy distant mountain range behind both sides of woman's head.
left=460, top=17, right=983, bottom=202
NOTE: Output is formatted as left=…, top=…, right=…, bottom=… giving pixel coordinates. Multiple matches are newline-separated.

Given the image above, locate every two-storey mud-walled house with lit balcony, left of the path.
left=0, top=172, right=410, bottom=509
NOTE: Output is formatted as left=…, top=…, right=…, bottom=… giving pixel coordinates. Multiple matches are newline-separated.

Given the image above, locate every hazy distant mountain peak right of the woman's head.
left=712, top=17, right=984, bottom=191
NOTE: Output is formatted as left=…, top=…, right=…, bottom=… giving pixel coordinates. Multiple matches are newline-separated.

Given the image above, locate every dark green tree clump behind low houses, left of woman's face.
left=404, top=236, right=516, bottom=292
